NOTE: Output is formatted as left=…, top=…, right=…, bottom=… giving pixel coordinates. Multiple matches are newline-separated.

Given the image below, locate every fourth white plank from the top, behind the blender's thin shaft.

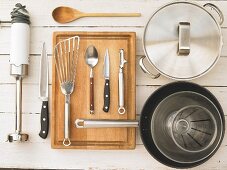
left=0, top=84, right=227, bottom=115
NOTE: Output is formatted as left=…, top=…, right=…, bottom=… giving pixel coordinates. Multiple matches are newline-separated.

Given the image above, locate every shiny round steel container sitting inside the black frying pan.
left=151, top=91, right=223, bottom=163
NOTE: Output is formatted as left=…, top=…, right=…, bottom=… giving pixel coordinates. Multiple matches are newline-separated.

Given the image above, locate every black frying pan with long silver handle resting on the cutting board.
left=75, top=82, right=225, bottom=168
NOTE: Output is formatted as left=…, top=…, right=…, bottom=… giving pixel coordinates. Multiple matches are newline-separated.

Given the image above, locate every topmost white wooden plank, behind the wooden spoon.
left=0, top=0, right=227, bottom=26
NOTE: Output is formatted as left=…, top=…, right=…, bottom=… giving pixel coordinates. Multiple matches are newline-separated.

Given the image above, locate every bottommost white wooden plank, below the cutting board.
left=0, top=140, right=227, bottom=170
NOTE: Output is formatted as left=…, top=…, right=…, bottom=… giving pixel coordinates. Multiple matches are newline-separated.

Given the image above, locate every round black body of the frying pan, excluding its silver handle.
left=140, top=82, right=225, bottom=168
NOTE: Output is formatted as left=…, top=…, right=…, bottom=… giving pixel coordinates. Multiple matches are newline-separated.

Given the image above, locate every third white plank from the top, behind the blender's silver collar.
left=0, top=55, right=227, bottom=86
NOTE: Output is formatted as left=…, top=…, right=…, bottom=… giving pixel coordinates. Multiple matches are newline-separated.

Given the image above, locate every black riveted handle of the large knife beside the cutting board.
left=39, top=101, right=49, bottom=139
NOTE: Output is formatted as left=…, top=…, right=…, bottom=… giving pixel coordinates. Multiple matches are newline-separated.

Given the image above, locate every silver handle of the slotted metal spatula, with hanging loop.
left=63, top=95, right=71, bottom=146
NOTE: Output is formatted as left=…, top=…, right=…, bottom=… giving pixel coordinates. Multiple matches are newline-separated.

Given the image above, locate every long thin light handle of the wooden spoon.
left=82, top=13, right=141, bottom=17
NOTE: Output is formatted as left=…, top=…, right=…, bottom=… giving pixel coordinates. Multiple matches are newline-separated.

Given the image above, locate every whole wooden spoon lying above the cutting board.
left=52, top=6, right=141, bottom=24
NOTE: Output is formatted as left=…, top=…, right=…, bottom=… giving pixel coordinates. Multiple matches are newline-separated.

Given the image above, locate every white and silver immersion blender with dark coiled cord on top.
left=8, top=3, right=30, bottom=142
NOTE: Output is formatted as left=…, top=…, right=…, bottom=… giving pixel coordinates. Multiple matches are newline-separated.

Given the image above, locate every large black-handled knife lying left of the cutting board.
left=39, top=43, right=49, bottom=139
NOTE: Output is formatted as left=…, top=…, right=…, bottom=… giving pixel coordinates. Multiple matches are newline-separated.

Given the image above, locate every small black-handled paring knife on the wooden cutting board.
left=103, top=48, right=110, bottom=112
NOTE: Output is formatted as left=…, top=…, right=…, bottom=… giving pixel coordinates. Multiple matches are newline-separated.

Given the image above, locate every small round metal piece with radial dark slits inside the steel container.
left=170, top=105, right=217, bottom=152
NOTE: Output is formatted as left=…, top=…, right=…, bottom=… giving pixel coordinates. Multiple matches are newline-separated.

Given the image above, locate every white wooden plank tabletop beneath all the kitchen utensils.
left=0, top=0, right=227, bottom=170
